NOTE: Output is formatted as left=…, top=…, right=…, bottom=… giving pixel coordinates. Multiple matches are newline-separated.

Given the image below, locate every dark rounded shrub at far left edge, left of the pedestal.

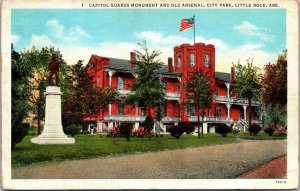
left=11, top=123, right=30, bottom=148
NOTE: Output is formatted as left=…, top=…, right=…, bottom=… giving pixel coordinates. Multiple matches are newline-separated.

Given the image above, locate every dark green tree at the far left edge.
left=11, top=44, right=32, bottom=148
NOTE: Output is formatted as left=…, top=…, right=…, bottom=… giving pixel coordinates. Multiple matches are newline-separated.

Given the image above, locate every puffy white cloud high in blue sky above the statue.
left=46, top=19, right=90, bottom=43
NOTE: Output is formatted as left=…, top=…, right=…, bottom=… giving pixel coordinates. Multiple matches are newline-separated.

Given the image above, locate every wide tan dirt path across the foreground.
left=13, top=140, right=286, bottom=179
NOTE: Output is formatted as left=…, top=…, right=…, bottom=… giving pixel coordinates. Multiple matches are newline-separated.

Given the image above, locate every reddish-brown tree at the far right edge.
left=262, top=53, right=287, bottom=107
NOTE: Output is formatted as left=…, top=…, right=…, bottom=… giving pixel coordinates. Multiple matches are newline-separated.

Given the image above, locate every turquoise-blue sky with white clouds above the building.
left=11, top=9, right=286, bottom=72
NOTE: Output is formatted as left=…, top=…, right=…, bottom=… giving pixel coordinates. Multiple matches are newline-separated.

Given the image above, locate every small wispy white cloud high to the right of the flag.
left=233, top=21, right=274, bottom=42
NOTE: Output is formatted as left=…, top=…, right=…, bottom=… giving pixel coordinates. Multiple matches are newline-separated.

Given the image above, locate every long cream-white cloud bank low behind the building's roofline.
left=25, top=31, right=277, bottom=72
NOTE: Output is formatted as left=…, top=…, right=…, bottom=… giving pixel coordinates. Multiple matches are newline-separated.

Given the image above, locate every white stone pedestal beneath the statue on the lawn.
left=31, top=86, right=75, bottom=144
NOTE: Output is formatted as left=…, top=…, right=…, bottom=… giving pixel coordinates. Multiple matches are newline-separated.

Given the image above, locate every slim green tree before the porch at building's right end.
left=233, top=59, right=261, bottom=130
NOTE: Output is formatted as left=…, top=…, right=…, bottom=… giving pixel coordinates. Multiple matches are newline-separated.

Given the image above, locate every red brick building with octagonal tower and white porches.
left=86, top=43, right=261, bottom=133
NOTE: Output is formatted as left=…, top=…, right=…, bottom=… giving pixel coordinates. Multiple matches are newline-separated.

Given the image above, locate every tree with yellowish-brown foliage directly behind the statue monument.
left=21, top=47, right=66, bottom=134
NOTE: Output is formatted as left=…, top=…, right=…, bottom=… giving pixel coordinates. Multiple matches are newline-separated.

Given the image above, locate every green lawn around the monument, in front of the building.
left=12, top=134, right=238, bottom=168
